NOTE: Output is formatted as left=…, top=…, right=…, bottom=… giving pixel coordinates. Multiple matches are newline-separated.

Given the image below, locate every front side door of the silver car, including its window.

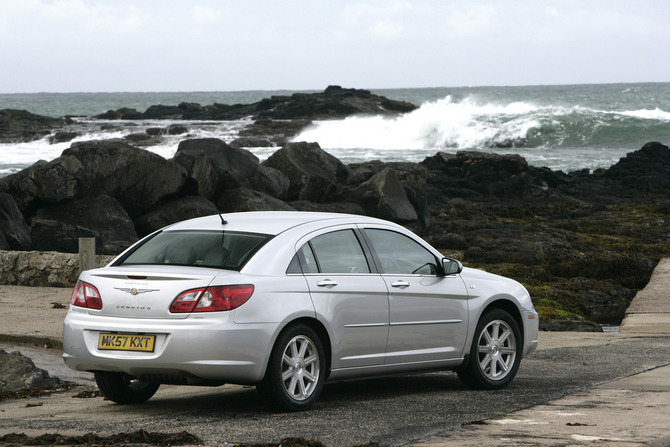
left=364, top=228, right=468, bottom=364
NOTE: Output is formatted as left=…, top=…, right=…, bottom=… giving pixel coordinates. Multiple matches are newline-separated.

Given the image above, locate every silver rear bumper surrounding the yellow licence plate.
left=63, top=312, right=277, bottom=383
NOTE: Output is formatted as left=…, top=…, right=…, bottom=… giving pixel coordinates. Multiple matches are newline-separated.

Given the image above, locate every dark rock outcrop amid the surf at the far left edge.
left=0, top=109, right=71, bottom=143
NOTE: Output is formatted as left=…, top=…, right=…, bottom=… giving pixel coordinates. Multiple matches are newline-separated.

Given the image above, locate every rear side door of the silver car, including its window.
left=297, top=228, right=389, bottom=370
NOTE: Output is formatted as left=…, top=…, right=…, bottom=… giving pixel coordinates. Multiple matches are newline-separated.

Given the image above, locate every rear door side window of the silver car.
left=312, top=230, right=370, bottom=273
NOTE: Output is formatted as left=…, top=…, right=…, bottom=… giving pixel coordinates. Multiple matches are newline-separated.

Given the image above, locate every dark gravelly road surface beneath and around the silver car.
left=0, top=332, right=670, bottom=447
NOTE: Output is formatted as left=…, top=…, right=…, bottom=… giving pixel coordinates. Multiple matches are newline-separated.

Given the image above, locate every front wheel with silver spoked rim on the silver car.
left=456, top=309, right=523, bottom=390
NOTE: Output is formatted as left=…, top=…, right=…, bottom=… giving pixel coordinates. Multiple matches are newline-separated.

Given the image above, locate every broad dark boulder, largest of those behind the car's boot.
left=61, top=140, right=195, bottom=217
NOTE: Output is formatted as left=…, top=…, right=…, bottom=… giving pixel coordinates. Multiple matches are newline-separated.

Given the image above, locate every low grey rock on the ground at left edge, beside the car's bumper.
left=0, top=349, right=62, bottom=393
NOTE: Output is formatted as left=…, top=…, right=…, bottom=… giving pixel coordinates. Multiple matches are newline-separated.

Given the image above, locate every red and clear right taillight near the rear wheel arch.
left=170, top=284, right=254, bottom=313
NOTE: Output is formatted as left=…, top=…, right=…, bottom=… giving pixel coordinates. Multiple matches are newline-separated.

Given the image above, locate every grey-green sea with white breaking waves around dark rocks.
left=0, top=83, right=670, bottom=176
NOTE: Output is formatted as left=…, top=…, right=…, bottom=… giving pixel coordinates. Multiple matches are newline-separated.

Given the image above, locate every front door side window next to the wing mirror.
left=365, top=228, right=438, bottom=275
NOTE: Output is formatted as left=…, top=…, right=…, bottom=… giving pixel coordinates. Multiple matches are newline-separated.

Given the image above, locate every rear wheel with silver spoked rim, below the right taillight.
left=256, top=325, right=326, bottom=411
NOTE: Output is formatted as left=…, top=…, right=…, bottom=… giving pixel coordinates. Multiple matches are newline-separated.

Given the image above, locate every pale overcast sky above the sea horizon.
left=0, top=0, right=670, bottom=93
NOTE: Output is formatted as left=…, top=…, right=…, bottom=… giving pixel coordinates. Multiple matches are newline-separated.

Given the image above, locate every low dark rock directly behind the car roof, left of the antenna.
left=135, top=196, right=219, bottom=237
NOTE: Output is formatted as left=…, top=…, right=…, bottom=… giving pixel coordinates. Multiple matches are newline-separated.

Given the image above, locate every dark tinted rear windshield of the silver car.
left=115, top=231, right=272, bottom=271
